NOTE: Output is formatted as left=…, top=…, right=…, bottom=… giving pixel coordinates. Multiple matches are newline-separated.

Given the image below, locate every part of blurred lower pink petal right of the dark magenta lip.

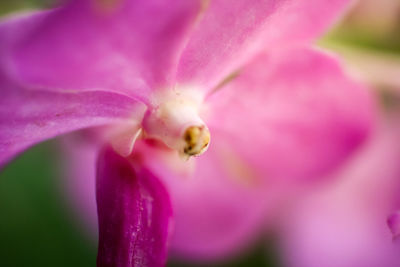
left=133, top=140, right=271, bottom=261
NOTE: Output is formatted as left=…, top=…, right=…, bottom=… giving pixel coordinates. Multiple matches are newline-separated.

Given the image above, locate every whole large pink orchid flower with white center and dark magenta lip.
left=0, top=0, right=373, bottom=266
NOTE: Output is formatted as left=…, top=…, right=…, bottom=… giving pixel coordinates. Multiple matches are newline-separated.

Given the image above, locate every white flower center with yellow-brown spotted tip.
left=142, top=91, right=210, bottom=157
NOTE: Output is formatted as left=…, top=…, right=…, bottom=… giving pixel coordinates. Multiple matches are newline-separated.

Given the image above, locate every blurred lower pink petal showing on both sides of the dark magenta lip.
left=63, top=135, right=272, bottom=261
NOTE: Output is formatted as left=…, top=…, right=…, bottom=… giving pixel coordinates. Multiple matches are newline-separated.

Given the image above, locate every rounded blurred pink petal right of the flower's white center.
left=206, top=48, right=374, bottom=180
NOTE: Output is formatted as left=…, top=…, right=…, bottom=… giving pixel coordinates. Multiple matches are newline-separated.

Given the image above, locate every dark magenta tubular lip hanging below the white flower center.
left=96, top=148, right=172, bottom=267
